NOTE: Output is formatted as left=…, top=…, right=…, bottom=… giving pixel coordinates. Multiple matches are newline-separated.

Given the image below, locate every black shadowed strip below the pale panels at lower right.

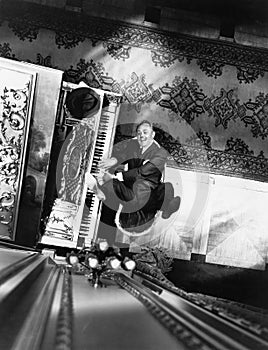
left=167, top=259, right=268, bottom=309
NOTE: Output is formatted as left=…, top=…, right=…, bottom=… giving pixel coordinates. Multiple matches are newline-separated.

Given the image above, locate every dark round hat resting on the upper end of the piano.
left=65, top=87, right=100, bottom=120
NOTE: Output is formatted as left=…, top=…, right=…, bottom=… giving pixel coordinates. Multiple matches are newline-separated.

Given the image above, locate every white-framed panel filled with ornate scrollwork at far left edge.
left=0, top=58, right=36, bottom=239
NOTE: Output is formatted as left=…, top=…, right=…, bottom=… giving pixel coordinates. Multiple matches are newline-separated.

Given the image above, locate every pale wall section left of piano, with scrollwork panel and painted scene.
left=0, top=58, right=63, bottom=246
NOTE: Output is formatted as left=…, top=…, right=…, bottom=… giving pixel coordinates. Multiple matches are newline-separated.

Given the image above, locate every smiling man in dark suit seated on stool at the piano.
left=87, top=120, right=180, bottom=232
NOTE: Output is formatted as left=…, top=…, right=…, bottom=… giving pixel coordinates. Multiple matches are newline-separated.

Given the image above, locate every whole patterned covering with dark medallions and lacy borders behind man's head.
left=0, top=3, right=268, bottom=182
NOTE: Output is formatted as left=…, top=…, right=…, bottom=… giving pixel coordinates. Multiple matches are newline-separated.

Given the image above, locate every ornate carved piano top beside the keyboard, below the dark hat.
left=43, top=116, right=97, bottom=243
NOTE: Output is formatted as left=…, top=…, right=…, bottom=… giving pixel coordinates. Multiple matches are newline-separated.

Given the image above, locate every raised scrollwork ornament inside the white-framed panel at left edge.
left=0, top=79, right=30, bottom=235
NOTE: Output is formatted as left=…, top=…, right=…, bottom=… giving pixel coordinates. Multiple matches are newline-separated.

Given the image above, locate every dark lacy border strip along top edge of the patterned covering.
left=0, top=1, right=268, bottom=74
